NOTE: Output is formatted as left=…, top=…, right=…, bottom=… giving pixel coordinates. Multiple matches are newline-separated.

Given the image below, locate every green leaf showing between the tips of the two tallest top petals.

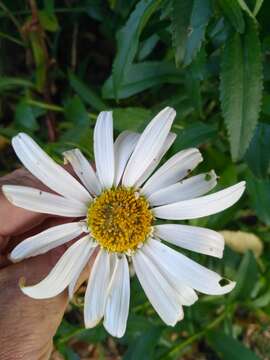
left=113, top=108, right=152, bottom=131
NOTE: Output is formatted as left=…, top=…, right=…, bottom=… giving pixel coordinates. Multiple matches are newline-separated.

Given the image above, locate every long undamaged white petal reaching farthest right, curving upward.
left=153, top=181, right=245, bottom=220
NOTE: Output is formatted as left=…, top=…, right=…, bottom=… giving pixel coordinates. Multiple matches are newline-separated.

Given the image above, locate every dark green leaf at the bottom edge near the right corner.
left=207, top=330, right=259, bottom=360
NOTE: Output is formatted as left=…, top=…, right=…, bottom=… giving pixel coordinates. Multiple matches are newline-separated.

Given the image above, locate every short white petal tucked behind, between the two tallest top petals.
left=114, top=131, right=140, bottom=186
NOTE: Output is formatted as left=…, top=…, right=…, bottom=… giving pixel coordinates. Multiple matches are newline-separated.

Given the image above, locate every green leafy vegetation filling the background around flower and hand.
left=0, top=0, right=270, bottom=360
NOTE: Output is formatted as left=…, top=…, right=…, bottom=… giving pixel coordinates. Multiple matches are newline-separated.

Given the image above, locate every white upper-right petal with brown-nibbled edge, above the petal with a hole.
left=142, top=148, right=202, bottom=196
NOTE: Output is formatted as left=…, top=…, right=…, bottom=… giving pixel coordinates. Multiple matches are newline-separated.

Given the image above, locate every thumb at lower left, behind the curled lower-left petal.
left=0, top=249, right=68, bottom=359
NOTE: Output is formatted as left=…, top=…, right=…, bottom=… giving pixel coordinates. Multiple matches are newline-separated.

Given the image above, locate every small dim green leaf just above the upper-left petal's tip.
left=15, top=100, right=39, bottom=131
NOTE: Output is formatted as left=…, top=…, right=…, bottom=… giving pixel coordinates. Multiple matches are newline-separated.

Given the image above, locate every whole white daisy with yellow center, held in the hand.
left=3, top=107, right=245, bottom=337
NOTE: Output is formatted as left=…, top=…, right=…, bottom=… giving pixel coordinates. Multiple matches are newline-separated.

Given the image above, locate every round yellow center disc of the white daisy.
left=87, top=187, right=153, bottom=253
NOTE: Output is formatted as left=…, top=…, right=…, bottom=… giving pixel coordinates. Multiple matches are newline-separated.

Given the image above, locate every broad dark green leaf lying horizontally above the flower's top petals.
left=102, top=61, right=183, bottom=99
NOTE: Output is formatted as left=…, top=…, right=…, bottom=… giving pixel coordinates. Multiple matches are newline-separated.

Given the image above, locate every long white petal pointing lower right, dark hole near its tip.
left=148, top=239, right=235, bottom=295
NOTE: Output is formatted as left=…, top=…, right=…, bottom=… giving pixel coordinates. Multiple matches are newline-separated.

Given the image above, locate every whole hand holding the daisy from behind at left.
left=0, top=169, right=92, bottom=360
